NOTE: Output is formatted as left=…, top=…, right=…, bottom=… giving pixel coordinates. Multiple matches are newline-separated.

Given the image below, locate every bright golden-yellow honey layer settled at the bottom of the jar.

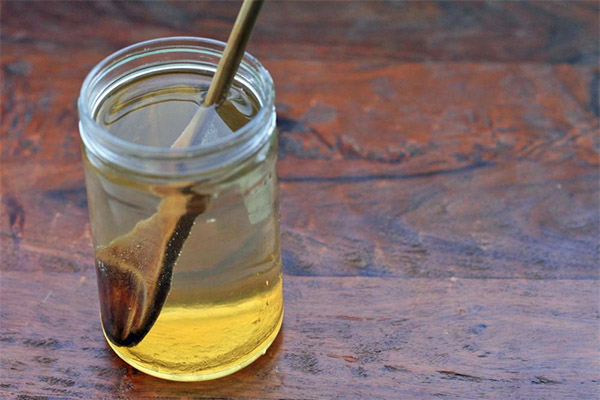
left=109, top=281, right=283, bottom=381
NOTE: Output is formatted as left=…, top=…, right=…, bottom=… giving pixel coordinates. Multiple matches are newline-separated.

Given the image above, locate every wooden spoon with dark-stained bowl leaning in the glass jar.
left=95, top=0, right=263, bottom=347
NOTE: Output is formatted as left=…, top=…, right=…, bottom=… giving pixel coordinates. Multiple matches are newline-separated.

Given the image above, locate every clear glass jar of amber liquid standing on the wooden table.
left=78, top=37, right=283, bottom=381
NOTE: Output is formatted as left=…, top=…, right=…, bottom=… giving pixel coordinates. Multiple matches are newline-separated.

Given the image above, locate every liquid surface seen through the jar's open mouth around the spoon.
left=96, top=72, right=258, bottom=147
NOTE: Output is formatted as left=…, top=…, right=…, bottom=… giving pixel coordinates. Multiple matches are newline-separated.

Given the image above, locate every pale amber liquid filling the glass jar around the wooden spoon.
left=86, top=69, right=283, bottom=381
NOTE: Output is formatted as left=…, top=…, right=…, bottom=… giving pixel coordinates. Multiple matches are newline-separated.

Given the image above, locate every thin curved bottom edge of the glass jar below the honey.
left=102, top=312, right=283, bottom=382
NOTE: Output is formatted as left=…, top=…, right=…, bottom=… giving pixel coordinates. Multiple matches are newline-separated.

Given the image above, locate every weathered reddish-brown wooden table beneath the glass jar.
left=0, top=1, right=600, bottom=399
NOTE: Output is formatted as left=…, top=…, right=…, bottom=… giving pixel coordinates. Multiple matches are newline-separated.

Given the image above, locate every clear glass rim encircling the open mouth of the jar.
left=77, top=36, right=275, bottom=171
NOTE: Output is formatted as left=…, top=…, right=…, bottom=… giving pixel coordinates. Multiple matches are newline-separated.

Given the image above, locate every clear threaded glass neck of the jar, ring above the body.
left=78, top=37, right=275, bottom=179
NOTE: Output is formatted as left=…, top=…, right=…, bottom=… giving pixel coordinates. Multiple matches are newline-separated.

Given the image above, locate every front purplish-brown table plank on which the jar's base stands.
left=0, top=274, right=600, bottom=399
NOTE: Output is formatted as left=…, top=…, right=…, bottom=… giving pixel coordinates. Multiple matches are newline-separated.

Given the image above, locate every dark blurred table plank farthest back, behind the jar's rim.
left=3, top=0, right=600, bottom=63
